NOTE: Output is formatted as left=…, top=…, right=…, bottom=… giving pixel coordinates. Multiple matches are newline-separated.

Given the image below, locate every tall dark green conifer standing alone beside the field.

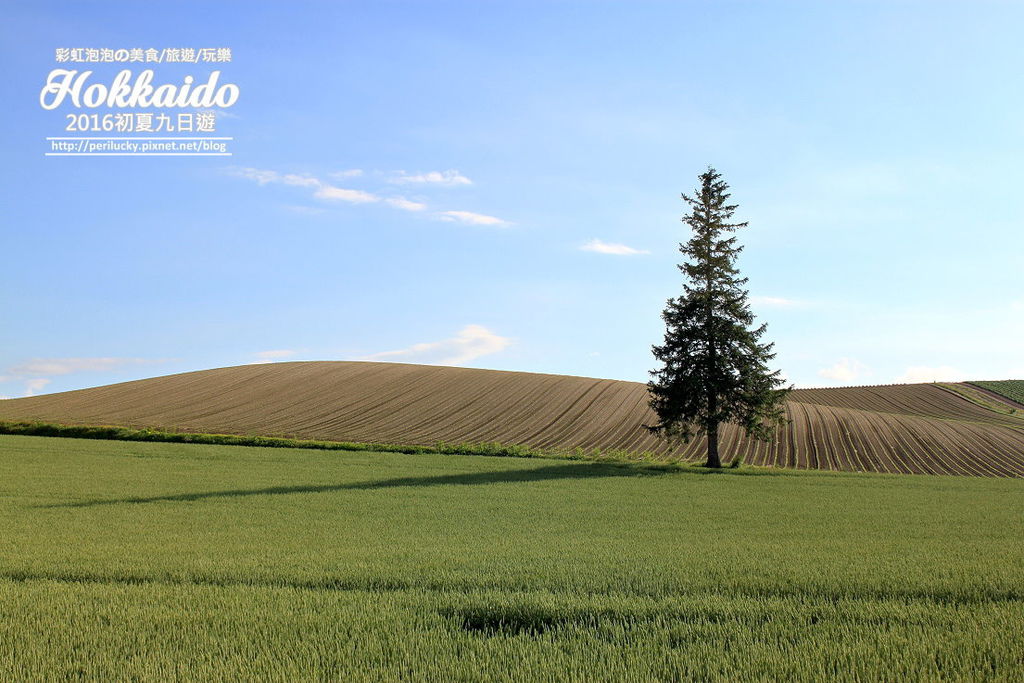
left=647, top=167, right=790, bottom=467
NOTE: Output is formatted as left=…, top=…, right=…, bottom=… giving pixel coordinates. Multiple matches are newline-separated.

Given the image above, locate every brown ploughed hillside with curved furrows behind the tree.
left=0, top=361, right=1024, bottom=477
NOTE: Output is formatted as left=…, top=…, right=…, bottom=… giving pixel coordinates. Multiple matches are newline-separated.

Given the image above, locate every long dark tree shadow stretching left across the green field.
left=38, top=464, right=684, bottom=508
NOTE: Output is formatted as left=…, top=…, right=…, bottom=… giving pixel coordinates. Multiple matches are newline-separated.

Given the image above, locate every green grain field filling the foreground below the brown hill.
left=0, top=436, right=1024, bottom=681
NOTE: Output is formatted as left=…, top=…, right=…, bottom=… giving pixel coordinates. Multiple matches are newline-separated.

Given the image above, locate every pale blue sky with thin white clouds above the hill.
left=0, top=0, right=1024, bottom=396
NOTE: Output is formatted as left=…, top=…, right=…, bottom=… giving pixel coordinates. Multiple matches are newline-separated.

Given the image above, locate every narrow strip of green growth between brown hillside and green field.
left=0, top=420, right=657, bottom=462
